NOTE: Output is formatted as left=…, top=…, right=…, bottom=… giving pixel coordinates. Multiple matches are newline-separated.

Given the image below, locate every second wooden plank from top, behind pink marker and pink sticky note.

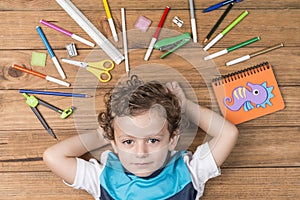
left=0, top=9, right=300, bottom=49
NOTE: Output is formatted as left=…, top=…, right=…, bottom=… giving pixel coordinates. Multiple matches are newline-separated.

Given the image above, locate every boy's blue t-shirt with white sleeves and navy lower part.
left=66, top=143, right=220, bottom=200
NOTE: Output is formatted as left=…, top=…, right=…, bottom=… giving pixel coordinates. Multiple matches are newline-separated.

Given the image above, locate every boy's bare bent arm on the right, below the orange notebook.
left=167, top=82, right=238, bottom=167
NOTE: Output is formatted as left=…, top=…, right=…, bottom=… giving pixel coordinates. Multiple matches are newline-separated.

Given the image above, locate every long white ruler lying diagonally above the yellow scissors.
left=56, top=0, right=124, bottom=64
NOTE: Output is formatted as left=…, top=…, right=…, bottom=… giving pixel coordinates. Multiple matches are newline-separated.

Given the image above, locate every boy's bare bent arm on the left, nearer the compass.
left=43, top=129, right=109, bottom=184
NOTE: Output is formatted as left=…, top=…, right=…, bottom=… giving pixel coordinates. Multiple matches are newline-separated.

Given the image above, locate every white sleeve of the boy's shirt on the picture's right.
left=184, top=142, right=221, bottom=193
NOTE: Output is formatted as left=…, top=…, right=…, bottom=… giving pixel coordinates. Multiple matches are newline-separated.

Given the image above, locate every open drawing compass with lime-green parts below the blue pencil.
left=22, top=93, right=75, bottom=139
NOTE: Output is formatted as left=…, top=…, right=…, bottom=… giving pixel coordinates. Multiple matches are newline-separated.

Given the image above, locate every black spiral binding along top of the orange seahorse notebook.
left=212, top=62, right=271, bottom=86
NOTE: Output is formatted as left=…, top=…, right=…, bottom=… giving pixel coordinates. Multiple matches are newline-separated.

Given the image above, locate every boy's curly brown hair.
left=98, top=76, right=181, bottom=140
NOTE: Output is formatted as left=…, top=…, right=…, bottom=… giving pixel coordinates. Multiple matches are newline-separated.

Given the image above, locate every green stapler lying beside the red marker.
left=154, top=32, right=191, bottom=59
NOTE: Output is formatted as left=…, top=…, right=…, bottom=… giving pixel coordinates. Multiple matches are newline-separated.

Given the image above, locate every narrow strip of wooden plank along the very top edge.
left=0, top=0, right=300, bottom=11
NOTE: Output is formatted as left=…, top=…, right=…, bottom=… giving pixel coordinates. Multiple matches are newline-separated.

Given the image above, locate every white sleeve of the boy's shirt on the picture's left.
left=64, top=158, right=104, bottom=199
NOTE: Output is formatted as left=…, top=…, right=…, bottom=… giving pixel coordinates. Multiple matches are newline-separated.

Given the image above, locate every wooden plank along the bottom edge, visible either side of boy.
left=0, top=168, right=300, bottom=200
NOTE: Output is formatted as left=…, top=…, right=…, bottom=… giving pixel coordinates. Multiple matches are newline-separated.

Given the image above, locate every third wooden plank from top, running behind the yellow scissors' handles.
left=0, top=47, right=300, bottom=89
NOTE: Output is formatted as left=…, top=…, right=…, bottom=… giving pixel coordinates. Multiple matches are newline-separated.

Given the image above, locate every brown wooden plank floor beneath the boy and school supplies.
left=0, top=0, right=300, bottom=200
